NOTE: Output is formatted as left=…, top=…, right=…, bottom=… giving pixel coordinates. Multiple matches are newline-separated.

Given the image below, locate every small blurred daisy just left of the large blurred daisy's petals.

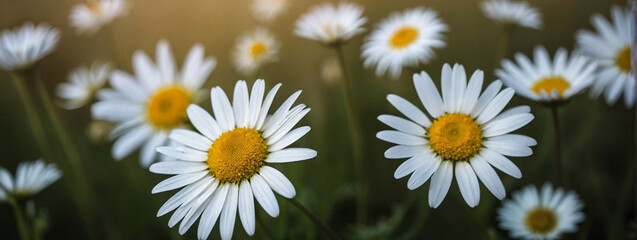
left=56, top=62, right=112, bottom=109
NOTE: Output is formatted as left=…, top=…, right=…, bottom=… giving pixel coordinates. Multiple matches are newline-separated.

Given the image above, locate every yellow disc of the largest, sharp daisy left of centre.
left=207, top=128, right=268, bottom=183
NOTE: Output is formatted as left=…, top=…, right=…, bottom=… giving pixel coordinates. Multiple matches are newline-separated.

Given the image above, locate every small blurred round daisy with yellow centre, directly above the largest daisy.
left=232, top=28, right=279, bottom=74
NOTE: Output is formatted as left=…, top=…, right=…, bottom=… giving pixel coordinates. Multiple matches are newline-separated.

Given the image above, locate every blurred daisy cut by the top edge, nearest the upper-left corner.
left=69, top=0, right=130, bottom=34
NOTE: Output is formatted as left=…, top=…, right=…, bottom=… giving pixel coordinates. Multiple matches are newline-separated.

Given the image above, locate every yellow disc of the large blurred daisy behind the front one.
left=146, top=86, right=192, bottom=129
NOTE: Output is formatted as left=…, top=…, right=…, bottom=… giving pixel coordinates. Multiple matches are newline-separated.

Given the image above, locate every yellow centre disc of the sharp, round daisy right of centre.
left=427, top=113, right=482, bottom=161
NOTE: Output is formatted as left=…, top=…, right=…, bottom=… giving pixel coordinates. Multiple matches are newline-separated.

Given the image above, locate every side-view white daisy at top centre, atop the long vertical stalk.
left=294, top=3, right=367, bottom=45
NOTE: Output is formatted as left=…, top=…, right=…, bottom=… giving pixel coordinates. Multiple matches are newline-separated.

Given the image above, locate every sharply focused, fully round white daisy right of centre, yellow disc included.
left=376, top=64, right=536, bottom=208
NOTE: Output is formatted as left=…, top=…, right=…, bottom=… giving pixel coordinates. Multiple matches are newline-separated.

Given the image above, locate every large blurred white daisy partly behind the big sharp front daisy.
left=91, top=41, right=216, bottom=166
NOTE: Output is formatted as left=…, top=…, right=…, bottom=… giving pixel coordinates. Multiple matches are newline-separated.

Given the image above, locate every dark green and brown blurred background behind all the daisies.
left=0, top=0, right=637, bottom=239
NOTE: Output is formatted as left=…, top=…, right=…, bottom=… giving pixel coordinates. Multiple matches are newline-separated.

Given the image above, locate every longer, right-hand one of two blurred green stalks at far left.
left=35, top=75, right=95, bottom=236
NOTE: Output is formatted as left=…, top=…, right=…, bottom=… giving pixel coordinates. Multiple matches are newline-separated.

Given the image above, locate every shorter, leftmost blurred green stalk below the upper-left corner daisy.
left=9, top=72, right=54, bottom=161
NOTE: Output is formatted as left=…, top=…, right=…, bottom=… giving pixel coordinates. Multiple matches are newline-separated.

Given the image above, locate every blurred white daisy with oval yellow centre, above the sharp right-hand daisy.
left=361, top=8, right=448, bottom=78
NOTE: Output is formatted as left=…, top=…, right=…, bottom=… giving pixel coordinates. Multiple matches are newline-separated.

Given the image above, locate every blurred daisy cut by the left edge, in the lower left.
left=0, top=159, right=62, bottom=198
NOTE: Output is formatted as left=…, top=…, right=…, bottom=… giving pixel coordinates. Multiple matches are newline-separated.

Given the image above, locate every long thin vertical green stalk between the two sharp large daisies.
left=334, top=45, right=367, bottom=224
